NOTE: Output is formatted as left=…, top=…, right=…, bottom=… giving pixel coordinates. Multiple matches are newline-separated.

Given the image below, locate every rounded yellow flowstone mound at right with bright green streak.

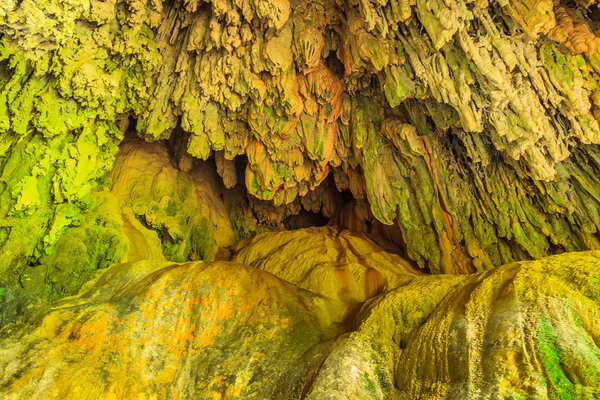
left=307, top=252, right=600, bottom=399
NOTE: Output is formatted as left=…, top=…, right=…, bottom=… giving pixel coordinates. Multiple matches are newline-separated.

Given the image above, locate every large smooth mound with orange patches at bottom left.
left=0, top=261, right=335, bottom=399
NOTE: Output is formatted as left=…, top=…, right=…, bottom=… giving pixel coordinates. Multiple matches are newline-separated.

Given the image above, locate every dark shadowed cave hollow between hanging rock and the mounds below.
left=117, top=128, right=418, bottom=264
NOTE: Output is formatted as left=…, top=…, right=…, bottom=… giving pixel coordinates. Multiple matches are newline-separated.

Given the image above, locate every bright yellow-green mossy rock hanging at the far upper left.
left=0, top=1, right=160, bottom=284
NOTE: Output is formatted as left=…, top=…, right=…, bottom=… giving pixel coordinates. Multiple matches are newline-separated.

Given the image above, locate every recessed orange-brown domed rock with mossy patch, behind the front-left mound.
left=108, top=139, right=235, bottom=262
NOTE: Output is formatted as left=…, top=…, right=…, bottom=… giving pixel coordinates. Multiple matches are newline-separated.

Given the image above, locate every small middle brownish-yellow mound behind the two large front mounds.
left=233, top=227, right=419, bottom=322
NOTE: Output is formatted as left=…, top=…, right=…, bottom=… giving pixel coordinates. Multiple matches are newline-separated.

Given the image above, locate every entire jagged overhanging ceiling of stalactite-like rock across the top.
left=0, top=0, right=600, bottom=280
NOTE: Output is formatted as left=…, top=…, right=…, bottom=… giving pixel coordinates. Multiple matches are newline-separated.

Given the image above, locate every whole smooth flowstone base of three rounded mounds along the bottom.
left=0, top=228, right=600, bottom=400
